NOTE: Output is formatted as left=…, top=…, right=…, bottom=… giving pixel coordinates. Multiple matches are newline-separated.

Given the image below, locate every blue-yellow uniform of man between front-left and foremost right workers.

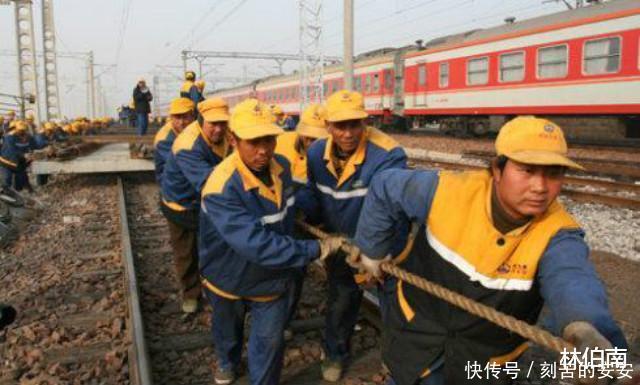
left=300, top=127, right=407, bottom=361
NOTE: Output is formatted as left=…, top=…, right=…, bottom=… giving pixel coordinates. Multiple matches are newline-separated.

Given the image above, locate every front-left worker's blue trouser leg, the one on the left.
left=206, top=290, right=246, bottom=371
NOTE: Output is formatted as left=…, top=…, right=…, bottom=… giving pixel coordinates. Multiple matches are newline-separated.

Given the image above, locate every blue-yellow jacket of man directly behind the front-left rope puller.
left=160, top=121, right=229, bottom=211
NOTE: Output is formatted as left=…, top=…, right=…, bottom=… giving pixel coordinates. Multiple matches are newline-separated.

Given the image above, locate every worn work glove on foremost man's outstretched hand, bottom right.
left=562, top=321, right=616, bottom=385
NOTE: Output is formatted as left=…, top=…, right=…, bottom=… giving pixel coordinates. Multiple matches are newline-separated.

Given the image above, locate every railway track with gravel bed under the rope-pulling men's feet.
left=119, top=176, right=383, bottom=385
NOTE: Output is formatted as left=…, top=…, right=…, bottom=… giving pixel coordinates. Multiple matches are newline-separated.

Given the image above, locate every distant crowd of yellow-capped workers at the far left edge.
left=0, top=111, right=113, bottom=193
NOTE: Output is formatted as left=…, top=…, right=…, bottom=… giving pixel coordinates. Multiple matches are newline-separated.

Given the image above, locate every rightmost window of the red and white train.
left=582, top=37, right=620, bottom=75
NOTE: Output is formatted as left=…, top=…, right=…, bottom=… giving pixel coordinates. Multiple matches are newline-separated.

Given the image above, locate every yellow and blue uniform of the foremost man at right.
left=355, top=170, right=627, bottom=385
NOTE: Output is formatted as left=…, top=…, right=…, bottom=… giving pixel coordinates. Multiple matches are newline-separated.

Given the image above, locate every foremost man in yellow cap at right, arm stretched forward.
left=355, top=117, right=627, bottom=385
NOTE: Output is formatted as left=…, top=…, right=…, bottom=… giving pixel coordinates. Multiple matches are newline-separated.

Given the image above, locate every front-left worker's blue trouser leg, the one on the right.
left=248, top=291, right=291, bottom=385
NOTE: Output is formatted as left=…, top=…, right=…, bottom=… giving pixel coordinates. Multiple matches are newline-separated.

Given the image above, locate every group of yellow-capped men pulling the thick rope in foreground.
left=150, top=72, right=627, bottom=385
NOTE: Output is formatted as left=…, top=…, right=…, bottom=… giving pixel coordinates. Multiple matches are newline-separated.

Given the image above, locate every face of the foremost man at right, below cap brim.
left=493, top=159, right=566, bottom=219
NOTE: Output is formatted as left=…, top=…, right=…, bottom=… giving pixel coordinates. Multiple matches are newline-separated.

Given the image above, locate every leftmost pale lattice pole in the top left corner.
left=14, top=0, right=40, bottom=125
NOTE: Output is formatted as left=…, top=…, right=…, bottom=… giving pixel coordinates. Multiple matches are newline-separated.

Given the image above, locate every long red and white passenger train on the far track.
left=208, top=0, right=640, bottom=138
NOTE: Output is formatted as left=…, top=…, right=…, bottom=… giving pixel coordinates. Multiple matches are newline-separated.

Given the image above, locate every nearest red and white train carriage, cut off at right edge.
left=404, top=0, right=640, bottom=136
